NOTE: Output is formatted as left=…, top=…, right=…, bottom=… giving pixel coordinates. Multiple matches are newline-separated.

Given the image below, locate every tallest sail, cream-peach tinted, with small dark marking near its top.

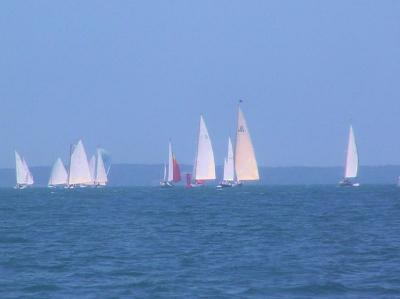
left=235, top=107, right=259, bottom=181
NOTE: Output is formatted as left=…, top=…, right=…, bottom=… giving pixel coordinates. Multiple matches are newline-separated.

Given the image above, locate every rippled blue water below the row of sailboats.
left=0, top=186, right=400, bottom=298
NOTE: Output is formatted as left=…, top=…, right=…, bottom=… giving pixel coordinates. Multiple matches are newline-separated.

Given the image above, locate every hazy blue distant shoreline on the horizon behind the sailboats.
left=0, top=163, right=400, bottom=187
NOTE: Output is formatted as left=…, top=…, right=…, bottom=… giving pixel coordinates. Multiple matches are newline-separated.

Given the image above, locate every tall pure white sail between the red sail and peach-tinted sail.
left=194, top=116, right=215, bottom=180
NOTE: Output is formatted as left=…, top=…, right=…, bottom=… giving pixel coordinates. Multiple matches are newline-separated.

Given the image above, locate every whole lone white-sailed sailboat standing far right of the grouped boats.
left=339, top=126, right=360, bottom=187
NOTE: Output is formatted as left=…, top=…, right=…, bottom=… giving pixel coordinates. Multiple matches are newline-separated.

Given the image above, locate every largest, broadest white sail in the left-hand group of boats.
left=68, top=140, right=93, bottom=185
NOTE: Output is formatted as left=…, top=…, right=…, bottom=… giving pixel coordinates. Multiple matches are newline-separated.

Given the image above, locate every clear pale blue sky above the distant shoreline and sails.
left=0, top=0, right=400, bottom=167
